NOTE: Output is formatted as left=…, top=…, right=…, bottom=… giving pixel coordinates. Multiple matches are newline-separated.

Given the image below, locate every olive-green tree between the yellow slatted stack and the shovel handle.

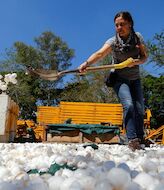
left=60, top=56, right=118, bottom=103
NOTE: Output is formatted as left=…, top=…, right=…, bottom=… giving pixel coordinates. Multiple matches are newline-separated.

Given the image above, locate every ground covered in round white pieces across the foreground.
left=0, top=143, right=164, bottom=190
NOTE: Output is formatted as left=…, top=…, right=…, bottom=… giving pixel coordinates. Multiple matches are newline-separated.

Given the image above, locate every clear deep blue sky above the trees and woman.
left=0, top=0, right=164, bottom=77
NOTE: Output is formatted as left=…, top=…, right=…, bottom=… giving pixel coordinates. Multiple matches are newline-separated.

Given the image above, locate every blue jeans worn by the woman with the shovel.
left=113, top=79, right=144, bottom=139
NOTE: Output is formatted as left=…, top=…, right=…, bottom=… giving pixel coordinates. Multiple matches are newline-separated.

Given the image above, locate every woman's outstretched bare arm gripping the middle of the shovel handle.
left=79, top=43, right=112, bottom=72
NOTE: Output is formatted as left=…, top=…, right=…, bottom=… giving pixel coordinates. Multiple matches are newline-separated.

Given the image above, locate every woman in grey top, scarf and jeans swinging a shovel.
left=79, top=12, right=147, bottom=151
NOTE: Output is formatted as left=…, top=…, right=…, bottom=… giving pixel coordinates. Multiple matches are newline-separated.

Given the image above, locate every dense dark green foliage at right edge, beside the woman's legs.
left=143, top=75, right=164, bottom=128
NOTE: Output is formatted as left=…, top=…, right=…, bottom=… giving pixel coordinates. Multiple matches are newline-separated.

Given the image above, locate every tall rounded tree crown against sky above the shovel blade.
left=35, top=32, right=74, bottom=71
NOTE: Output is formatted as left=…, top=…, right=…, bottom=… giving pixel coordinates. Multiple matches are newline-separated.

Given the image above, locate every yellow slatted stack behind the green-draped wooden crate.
left=37, top=102, right=123, bottom=126
